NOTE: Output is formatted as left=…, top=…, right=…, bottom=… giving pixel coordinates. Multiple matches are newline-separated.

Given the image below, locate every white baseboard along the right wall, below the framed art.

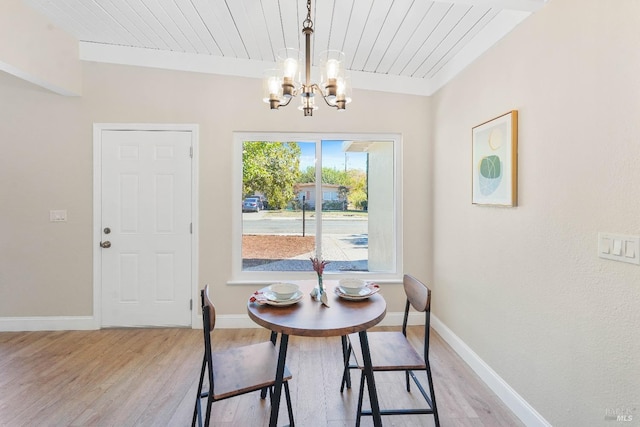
left=431, top=314, right=551, bottom=427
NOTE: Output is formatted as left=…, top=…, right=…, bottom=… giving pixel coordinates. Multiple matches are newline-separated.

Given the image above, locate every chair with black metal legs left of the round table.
left=191, top=285, right=295, bottom=427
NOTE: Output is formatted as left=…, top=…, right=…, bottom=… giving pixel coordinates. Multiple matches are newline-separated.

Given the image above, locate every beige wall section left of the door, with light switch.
left=0, top=72, right=93, bottom=318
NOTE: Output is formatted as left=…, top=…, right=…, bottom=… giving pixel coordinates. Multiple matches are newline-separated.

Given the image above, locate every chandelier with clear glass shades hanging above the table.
left=263, top=0, right=351, bottom=117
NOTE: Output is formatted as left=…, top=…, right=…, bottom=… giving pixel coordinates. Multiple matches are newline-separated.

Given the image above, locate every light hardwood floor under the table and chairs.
left=0, top=327, right=522, bottom=427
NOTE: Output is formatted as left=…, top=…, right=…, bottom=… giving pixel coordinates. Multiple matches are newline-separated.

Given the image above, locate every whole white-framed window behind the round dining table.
left=233, top=133, right=402, bottom=282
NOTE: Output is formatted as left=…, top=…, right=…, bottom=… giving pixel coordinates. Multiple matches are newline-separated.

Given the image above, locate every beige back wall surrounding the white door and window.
left=0, top=63, right=431, bottom=318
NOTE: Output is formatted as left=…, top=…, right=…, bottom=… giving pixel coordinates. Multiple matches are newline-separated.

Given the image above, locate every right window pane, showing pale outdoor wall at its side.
left=321, top=141, right=395, bottom=272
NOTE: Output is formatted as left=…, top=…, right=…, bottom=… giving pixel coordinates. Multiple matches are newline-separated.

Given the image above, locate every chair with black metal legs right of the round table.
left=340, top=274, right=440, bottom=426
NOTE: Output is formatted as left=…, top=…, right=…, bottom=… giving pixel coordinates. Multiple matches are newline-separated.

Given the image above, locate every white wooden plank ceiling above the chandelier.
left=23, top=0, right=546, bottom=94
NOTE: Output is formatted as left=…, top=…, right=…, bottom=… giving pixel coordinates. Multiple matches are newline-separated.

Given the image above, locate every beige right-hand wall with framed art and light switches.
left=433, top=0, right=640, bottom=426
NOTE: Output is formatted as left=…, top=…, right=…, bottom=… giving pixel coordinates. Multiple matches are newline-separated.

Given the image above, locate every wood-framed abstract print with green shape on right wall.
left=471, top=110, right=518, bottom=207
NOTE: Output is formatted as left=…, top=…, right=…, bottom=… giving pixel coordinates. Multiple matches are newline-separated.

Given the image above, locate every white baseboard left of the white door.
left=0, top=316, right=100, bottom=332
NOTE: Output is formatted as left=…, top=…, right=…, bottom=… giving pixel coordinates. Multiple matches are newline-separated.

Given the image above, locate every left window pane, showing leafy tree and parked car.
left=242, top=141, right=315, bottom=271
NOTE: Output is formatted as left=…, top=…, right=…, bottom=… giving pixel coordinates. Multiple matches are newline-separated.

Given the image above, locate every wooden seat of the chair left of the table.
left=211, top=341, right=291, bottom=400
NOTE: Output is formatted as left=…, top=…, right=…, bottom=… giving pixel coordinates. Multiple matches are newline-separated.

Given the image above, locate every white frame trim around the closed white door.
left=93, top=123, right=200, bottom=329
